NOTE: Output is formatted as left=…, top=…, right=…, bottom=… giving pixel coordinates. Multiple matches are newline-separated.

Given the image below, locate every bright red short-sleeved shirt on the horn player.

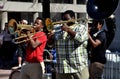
left=25, top=32, right=47, bottom=63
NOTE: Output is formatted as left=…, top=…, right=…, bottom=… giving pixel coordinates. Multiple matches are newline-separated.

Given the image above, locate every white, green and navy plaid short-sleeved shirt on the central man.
left=55, top=24, right=88, bottom=73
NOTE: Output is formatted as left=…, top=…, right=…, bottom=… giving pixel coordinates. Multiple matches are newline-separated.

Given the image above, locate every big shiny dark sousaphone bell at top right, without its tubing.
left=87, top=0, right=119, bottom=19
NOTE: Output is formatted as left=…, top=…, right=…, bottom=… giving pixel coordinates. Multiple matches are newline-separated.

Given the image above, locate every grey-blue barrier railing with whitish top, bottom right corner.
left=102, top=52, right=120, bottom=79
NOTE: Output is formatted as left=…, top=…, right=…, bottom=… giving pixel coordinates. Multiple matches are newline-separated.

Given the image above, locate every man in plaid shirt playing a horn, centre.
left=49, top=10, right=89, bottom=79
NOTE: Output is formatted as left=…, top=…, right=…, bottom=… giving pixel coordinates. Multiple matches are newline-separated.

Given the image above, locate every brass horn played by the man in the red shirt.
left=8, top=19, right=34, bottom=44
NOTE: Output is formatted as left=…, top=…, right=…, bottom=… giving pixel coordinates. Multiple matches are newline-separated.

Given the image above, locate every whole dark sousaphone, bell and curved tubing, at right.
left=87, top=0, right=119, bottom=48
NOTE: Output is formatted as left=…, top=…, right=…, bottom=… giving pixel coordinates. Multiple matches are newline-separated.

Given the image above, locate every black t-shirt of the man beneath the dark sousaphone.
left=91, top=30, right=107, bottom=64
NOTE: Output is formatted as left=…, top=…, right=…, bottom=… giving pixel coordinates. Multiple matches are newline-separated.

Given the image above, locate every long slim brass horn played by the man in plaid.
left=45, top=18, right=88, bottom=32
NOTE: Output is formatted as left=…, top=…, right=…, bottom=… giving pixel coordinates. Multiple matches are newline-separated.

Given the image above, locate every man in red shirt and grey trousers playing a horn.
left=20, top=17, right=47, bottom=79
